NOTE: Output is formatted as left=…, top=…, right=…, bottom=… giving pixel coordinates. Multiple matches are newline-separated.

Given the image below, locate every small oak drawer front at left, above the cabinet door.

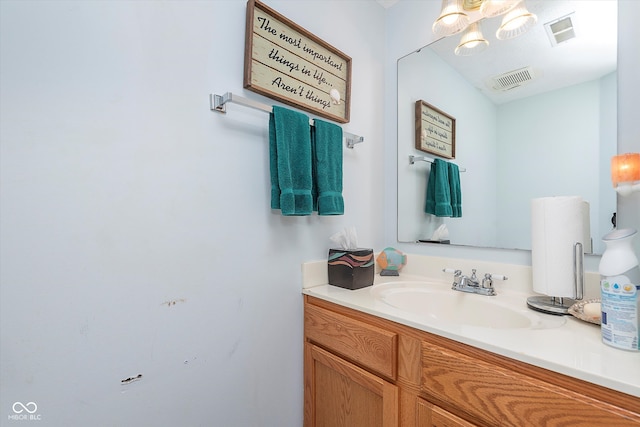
left=304, top=304, right=398, bottom=380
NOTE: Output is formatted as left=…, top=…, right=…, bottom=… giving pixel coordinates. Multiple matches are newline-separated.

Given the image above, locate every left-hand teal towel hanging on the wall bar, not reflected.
left=269, top=106, right=313, bottom=216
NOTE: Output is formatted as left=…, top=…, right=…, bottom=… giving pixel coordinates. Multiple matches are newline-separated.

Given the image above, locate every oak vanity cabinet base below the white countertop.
left=304, top=296, right=640, bottom=427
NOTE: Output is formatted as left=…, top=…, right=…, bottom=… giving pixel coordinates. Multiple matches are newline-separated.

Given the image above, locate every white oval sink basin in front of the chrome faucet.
left=371, top=281, right=566, bottom=329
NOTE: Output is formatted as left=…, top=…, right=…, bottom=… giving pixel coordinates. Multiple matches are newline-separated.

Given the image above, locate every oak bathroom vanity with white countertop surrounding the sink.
left=303, top=258, right=640, bottom=427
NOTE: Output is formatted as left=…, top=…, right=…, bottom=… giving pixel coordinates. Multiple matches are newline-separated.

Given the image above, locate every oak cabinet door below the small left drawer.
left=304, top=343, right=398, bottom=427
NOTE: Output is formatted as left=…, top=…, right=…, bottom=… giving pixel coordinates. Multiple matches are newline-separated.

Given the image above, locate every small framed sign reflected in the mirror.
left=416, top=100, right=456, bottom=159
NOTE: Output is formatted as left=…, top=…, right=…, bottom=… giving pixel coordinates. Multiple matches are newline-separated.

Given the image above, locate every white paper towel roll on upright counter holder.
left=531, top=196, right=588, bottom=298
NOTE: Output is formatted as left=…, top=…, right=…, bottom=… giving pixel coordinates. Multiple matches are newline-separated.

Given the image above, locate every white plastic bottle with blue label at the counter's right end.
left=599, top=229, right=640, bottom=351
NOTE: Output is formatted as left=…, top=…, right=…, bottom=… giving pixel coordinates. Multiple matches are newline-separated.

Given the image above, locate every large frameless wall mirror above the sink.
left=398, top=0, right=618, bottom=254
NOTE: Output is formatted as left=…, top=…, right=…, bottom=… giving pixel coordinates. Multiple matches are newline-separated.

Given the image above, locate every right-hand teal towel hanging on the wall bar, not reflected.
left=311, top=119, right=344, bottom=215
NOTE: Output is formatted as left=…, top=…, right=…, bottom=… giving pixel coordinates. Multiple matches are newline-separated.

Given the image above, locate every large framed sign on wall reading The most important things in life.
left=244, top=0, right=351, bottom=123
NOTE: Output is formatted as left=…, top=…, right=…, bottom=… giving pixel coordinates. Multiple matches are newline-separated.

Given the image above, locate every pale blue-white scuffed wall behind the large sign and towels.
left=0, top=0, right=385, bottom=427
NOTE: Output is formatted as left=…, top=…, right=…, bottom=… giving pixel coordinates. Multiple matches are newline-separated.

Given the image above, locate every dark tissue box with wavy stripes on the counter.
left=328, top=249, right=375, bottom=290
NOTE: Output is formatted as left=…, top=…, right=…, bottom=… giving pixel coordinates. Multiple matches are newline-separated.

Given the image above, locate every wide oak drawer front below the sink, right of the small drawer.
left=421, top=342, right=640, bottom=427
